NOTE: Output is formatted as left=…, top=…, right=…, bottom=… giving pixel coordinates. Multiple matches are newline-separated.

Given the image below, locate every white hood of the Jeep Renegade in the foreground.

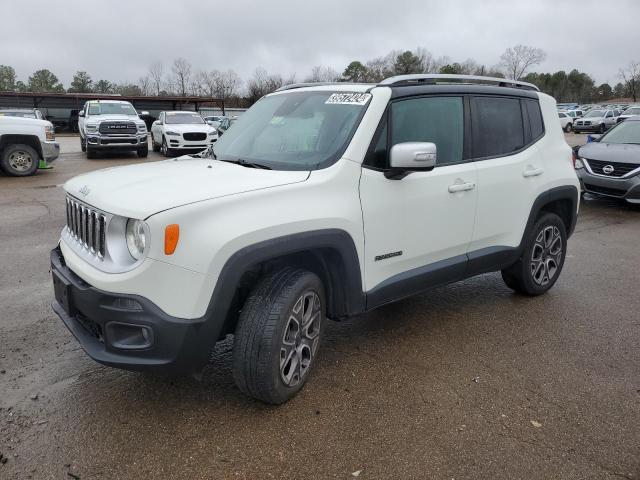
left=64, top=156, right=309, bottom=219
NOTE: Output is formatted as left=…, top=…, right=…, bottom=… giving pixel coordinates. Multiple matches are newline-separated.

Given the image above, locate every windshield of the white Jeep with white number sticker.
left=214, top=91, right=371, bottom=170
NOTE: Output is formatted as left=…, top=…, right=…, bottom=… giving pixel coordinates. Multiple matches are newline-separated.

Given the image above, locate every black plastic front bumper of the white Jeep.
left=51, top=247, right=210, bottom=373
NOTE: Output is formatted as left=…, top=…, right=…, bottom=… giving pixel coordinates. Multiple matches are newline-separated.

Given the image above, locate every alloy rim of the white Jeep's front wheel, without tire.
left=280, top=291, right=322, bottom=387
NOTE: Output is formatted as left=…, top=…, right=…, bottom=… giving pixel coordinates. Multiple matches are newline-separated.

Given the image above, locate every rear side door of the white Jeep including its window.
left=469, top=96, right=550, bottom=255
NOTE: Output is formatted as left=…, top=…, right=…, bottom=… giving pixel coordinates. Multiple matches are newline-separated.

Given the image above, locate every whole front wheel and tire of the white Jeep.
left=233, top=267, right=326, bottom=405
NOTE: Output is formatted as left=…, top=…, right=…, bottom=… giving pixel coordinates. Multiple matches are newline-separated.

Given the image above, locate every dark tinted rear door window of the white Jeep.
left=471, top=97, right=524, bottom=158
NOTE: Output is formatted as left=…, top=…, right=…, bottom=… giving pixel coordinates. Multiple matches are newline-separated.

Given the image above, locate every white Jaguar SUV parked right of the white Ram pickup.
left=151, top=111, right=218, bottom=157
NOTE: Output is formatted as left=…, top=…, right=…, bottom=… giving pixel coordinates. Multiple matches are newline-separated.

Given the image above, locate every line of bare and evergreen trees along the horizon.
left=0, top=45, right=640, bottom=105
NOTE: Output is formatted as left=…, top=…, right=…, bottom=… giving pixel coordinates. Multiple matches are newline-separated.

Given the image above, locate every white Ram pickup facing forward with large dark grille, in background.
left=78, top=100, right=149, bottom=158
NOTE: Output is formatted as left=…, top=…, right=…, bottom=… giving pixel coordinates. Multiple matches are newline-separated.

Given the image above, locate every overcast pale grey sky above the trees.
left=0, top=0, right=640, bottom=86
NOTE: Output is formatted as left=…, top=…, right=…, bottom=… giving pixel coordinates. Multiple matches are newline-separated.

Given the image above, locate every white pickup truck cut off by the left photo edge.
left=0, top=115, right=60, bottom=177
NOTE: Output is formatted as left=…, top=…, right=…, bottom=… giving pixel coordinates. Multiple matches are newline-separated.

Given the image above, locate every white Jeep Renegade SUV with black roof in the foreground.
left=51, top=75, right=579, bottom=404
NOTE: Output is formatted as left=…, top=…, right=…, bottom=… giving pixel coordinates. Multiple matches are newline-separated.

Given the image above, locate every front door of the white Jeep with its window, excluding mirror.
left=360, top=96, right=477, bottom=307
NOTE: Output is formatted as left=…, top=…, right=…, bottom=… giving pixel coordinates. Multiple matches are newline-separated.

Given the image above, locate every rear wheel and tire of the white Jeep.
left=502, top=213, right=567, bottom=296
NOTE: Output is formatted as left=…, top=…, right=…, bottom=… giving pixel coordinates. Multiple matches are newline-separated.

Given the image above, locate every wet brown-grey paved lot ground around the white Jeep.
left=0, top=135, right=640, bottom=480
